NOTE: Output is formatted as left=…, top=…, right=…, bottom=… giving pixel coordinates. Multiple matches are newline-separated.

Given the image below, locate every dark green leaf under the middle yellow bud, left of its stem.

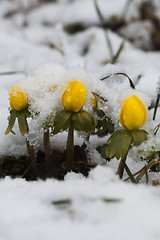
left=52, top=110, right=72, bottom=134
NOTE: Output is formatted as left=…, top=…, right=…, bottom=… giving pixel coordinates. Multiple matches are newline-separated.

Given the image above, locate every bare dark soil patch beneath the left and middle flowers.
left=0, top=145, right=96, bottom=181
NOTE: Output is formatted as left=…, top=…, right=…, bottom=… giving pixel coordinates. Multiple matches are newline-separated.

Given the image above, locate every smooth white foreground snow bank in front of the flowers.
left=0, top=166, right=160, bottom=240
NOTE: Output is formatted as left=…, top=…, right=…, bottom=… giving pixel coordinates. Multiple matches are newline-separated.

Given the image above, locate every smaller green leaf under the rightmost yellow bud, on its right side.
left=130, top=129, right=148, bottom=146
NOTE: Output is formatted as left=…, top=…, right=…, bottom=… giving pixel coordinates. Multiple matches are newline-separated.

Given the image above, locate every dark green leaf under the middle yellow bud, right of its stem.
left=72, top=110, right=96, bottom=133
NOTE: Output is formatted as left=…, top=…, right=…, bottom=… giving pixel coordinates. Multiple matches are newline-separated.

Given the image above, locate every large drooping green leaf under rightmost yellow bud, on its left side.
left=106, top=130, right=133, bottom=159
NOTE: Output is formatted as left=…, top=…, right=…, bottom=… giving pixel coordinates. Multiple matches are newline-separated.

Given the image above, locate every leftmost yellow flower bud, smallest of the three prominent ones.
left=9, top=86, right=28, bottom=111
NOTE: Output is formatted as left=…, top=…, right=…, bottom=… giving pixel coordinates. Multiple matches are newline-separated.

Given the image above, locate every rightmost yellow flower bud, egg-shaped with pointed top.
left=119, top=95, right=147, bottom=130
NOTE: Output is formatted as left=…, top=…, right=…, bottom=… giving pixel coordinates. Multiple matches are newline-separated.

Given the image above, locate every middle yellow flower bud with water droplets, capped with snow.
left=61, top=80, right=87, bottom=112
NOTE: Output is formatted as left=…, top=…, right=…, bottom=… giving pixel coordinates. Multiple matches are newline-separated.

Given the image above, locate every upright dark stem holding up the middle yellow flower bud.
left=66, top=118, right=74, bottom=172
